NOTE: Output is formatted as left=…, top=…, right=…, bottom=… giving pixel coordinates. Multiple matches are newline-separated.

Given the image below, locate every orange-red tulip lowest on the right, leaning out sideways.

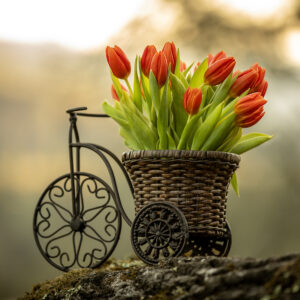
left=234, top=92, right=267, bottom=128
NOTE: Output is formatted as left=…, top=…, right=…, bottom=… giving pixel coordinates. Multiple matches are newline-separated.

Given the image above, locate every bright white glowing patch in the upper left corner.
left=0, top=0, right=145, bottom=49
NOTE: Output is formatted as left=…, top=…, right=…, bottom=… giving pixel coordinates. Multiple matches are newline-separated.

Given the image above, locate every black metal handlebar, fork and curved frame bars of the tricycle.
left=67, top=107, right=133, bottom=226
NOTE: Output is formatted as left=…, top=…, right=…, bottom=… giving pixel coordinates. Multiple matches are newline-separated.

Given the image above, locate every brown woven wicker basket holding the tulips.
left=122, top=150, right=240, bottom=236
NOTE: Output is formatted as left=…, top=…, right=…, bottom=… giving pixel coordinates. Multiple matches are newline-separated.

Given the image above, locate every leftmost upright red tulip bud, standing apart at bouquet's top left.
left=106, top=46, right=131, bottom=79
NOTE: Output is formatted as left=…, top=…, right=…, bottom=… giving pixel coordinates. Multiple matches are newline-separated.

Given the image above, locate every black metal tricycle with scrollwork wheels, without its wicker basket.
left=33, top=107, right=231, bottom=271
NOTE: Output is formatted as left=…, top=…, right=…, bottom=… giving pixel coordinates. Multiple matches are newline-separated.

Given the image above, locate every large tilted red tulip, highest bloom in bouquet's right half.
left=204, top=51, right=235, bottom=85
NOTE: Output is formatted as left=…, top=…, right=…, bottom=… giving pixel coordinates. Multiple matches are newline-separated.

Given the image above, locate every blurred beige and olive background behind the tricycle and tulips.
left=0, top=0, right=300, bottom=299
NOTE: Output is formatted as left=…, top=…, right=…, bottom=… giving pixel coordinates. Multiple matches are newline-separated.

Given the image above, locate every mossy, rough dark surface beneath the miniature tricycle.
left=19, top=254, right=300, bottom=300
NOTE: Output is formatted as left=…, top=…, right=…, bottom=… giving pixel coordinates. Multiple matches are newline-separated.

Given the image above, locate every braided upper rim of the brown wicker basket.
left=122, top=150, right=241, bottom=164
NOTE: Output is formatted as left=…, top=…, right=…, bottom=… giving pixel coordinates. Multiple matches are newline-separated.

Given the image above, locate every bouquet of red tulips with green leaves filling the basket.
left=103, top=42, right=272, bottom=196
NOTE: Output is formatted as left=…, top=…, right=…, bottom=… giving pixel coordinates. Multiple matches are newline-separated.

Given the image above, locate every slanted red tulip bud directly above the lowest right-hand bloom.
left=229, top=69, right=258, bottom=98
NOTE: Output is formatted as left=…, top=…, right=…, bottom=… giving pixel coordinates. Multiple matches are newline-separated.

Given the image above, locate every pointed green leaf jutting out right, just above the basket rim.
left=231, top=132, right=273, bottom=154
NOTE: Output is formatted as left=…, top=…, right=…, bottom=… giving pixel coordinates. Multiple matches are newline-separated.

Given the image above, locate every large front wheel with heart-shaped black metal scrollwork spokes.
left=33, top=172, right=122, bottom=271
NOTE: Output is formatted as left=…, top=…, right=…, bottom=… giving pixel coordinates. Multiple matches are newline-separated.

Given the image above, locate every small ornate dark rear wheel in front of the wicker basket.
left=131, top=202, right=188, bottom=264
